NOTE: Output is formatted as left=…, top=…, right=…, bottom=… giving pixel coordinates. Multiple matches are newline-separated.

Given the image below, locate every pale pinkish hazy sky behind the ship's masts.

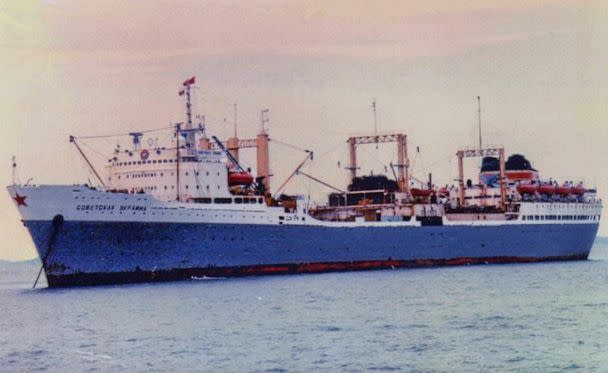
left=0, top=0, right=608, bottom=260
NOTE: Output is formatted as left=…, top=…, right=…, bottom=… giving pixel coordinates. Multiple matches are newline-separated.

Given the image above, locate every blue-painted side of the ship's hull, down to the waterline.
left=25, top=221, right=598, bottom=286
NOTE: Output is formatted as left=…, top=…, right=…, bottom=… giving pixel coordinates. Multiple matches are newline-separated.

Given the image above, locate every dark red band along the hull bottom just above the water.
left=47, top=255, right=587, bottom=287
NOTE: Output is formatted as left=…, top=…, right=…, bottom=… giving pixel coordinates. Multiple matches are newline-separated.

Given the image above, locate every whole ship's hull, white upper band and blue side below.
left=9, top=186, right=601, bottom=287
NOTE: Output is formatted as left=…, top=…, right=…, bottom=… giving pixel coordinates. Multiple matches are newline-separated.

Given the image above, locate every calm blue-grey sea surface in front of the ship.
left=0, top=245, right=608, bottom=372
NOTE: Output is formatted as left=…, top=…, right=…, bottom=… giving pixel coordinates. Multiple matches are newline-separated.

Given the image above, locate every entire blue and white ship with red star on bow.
left=7, top=77, right=602, bottom=287
